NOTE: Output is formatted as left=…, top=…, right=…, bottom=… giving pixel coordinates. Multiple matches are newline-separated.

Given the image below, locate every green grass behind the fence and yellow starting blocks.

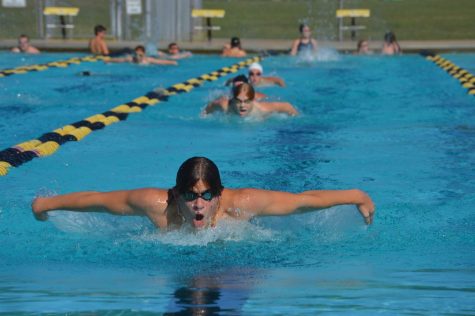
left=0, top=0, right=475, bottom=40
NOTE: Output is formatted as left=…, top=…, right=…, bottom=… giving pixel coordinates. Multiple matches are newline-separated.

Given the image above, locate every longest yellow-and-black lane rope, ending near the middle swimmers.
left=0, top=56, right=262, bottom=176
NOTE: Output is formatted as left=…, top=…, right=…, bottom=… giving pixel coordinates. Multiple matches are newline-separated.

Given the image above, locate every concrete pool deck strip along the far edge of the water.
left=0, top=38, right=475, bottom=54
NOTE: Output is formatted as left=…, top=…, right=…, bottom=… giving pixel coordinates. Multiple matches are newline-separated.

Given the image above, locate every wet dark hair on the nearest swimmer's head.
left=174, top=157, right=224, bottom=196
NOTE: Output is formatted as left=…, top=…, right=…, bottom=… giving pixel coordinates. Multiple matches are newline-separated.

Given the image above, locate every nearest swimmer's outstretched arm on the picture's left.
left=31, top=189, right=167, bottom=220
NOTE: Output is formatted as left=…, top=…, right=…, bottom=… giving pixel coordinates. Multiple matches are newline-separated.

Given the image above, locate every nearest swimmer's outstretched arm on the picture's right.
left=233, top=189, right=375, bottom=224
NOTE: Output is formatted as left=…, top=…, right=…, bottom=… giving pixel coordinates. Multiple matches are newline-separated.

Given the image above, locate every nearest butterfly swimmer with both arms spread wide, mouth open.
left=32, top=157, right=374, bottom=229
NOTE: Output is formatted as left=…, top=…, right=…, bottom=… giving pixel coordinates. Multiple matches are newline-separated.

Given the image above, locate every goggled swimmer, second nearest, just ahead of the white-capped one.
left=203, top=83, right=298, bottom=117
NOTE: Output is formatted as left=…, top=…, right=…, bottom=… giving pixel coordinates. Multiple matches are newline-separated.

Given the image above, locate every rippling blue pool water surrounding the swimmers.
left=0, top=52, right=475, bottom=315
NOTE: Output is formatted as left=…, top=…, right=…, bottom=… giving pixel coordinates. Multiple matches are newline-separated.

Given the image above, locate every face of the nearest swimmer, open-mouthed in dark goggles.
left=179, top=180, right=219, bottom=229
